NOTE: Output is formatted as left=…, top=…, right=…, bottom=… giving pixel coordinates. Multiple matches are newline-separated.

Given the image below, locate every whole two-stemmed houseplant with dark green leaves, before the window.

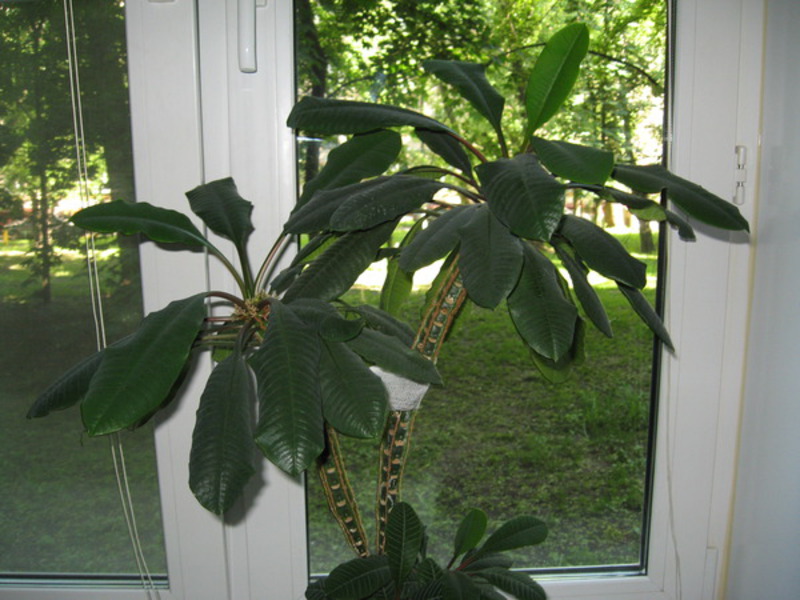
left=29, top=25, right=748, bottom=599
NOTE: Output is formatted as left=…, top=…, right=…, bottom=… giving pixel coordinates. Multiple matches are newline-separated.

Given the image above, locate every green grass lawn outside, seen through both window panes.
left=0, top=230, right=654, bottom=573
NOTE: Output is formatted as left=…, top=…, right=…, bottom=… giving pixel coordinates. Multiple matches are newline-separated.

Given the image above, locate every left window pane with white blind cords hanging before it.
left=0, top=0, right=166, bottom=577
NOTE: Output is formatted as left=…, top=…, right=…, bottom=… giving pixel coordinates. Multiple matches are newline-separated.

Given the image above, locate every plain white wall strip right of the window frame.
left=726, top=0, right=800, bottom=600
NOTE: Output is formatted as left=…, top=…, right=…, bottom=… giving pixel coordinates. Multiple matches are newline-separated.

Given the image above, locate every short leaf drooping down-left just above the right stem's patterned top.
left=399, top=204, right=479, bottom=273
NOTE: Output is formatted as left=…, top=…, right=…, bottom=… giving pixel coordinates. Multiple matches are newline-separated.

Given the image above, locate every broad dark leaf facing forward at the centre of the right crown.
left=476, top=154, right=564, bottom=241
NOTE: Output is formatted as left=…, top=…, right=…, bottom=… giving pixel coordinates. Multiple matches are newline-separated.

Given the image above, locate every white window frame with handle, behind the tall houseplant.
left=1, top=0, right=764, bottom=600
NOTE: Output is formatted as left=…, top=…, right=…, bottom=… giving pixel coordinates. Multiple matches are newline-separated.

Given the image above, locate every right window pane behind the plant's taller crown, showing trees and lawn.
left=295, top=0, right=666, bottom=573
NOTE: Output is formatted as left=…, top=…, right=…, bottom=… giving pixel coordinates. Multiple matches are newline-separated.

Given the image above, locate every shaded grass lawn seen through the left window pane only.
left=0, top=242, right=166, bottom=574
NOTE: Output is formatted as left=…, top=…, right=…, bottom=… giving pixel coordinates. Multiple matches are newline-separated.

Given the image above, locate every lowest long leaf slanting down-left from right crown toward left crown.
left=284, top=222, right=395, bottom=302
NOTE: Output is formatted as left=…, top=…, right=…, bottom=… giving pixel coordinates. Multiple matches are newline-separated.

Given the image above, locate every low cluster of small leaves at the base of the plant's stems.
left=306, top=502, right=547, bottom=600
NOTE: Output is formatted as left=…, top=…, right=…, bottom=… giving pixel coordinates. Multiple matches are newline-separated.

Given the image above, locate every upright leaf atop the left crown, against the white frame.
left=186, top=177, right=253, bottom=253
